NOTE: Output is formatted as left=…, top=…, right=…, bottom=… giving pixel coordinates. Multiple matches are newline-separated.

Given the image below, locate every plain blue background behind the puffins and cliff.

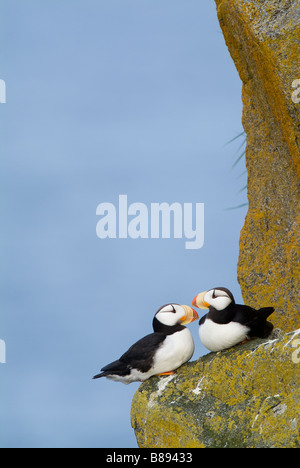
left=0, top=0, right=246, bottom=447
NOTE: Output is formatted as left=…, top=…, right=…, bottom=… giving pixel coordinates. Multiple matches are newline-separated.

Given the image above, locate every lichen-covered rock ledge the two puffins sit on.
left=132, top=330, right=300, bottom=448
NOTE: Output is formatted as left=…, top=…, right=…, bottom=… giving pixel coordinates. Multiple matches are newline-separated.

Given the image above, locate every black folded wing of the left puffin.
left=120, top=333, right=166, bottom=372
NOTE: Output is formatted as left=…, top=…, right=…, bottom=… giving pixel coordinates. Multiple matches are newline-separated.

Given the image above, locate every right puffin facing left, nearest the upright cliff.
left=192, top=287, right=274, bottom=352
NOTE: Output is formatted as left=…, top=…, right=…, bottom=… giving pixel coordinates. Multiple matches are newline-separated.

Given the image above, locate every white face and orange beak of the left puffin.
left=155, top=304, right=199, bottom=327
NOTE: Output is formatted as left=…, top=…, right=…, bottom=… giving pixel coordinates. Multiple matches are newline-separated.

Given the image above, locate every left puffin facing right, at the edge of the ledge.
left=93, top=303, right=199, bottom=385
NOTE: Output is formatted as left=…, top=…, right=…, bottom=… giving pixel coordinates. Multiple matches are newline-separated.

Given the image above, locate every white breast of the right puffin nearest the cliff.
left=199, top=318, right=250, bottom=352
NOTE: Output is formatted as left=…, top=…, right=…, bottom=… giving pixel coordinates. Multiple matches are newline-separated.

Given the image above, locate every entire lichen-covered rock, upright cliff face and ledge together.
left=132, top=0, right=300, bottom=448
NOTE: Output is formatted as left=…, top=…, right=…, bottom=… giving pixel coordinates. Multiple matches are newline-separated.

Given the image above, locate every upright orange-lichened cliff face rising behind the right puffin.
left=216, top=0, right=300, bottom=331
